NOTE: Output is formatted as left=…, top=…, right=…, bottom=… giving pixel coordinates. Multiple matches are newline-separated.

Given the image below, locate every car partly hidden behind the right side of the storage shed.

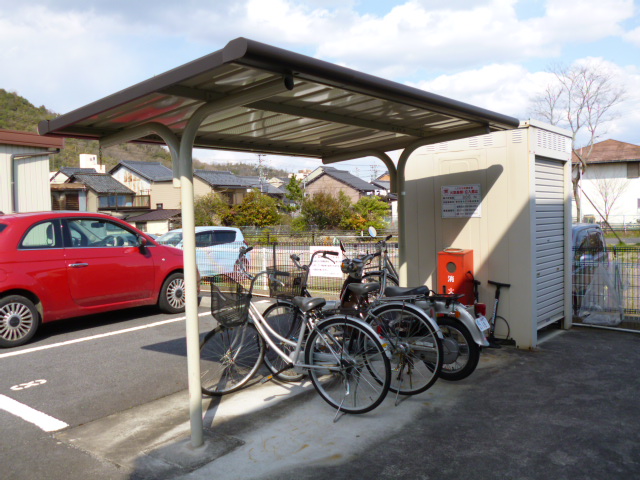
left=571, top=223, right=609, bottom=313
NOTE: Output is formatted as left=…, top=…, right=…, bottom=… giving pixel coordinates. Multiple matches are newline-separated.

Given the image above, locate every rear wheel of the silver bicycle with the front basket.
left=305, top=317, right=391, bottom=413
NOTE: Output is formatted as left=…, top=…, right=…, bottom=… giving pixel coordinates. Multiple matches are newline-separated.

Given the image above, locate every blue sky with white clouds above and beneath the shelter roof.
left=0, top=0, right=640, bottom=180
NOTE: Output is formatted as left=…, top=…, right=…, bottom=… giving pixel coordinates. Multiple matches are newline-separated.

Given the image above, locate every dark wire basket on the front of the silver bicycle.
left=210, top=274, right=251, bottom=327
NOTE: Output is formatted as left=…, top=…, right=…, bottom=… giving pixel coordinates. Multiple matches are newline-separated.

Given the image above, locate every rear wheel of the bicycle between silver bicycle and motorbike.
left=366, top=303, right=444, bottom=395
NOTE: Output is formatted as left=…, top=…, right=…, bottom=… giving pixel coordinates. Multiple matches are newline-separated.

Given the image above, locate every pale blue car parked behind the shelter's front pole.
left=157, top=227, right=247, bottom=277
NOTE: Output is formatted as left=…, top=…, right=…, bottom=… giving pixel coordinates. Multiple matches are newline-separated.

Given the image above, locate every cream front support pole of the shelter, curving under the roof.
left=179, top=78, right=291, bottom=448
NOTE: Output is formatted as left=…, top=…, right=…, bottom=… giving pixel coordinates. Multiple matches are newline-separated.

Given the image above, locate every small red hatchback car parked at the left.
left=0, top=212, right=190, bottom=347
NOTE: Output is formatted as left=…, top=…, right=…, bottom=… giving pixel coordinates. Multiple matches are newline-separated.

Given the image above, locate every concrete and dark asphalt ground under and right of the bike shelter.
left=42, top=327, right=640, bottom=480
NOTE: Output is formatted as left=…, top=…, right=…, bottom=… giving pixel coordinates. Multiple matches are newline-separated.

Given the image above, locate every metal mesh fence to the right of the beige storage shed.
left=572, top=246, right=640, bottom=330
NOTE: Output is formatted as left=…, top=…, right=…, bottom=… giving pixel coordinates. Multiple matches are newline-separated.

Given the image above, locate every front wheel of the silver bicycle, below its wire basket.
left=200, top=322, right=265, bottom=396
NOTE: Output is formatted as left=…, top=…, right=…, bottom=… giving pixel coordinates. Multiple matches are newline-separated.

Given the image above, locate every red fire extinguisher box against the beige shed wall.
left=437, top=248, right=474, bottom=305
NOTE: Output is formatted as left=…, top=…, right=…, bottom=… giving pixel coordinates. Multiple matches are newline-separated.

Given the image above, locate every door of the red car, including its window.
left=65, top=218, right=155, bottom=307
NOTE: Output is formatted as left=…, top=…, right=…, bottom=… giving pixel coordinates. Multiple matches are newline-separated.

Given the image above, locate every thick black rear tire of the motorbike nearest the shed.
left=437, top=316, right=480, bottom=381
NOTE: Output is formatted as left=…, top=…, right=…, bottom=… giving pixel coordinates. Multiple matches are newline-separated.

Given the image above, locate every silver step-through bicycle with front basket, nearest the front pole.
left=200, top=247, right=391, bottom=416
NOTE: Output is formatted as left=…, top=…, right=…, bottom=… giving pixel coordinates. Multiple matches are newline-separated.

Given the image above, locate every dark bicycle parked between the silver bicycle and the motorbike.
left=264, top=246, right=446, bottom=395
